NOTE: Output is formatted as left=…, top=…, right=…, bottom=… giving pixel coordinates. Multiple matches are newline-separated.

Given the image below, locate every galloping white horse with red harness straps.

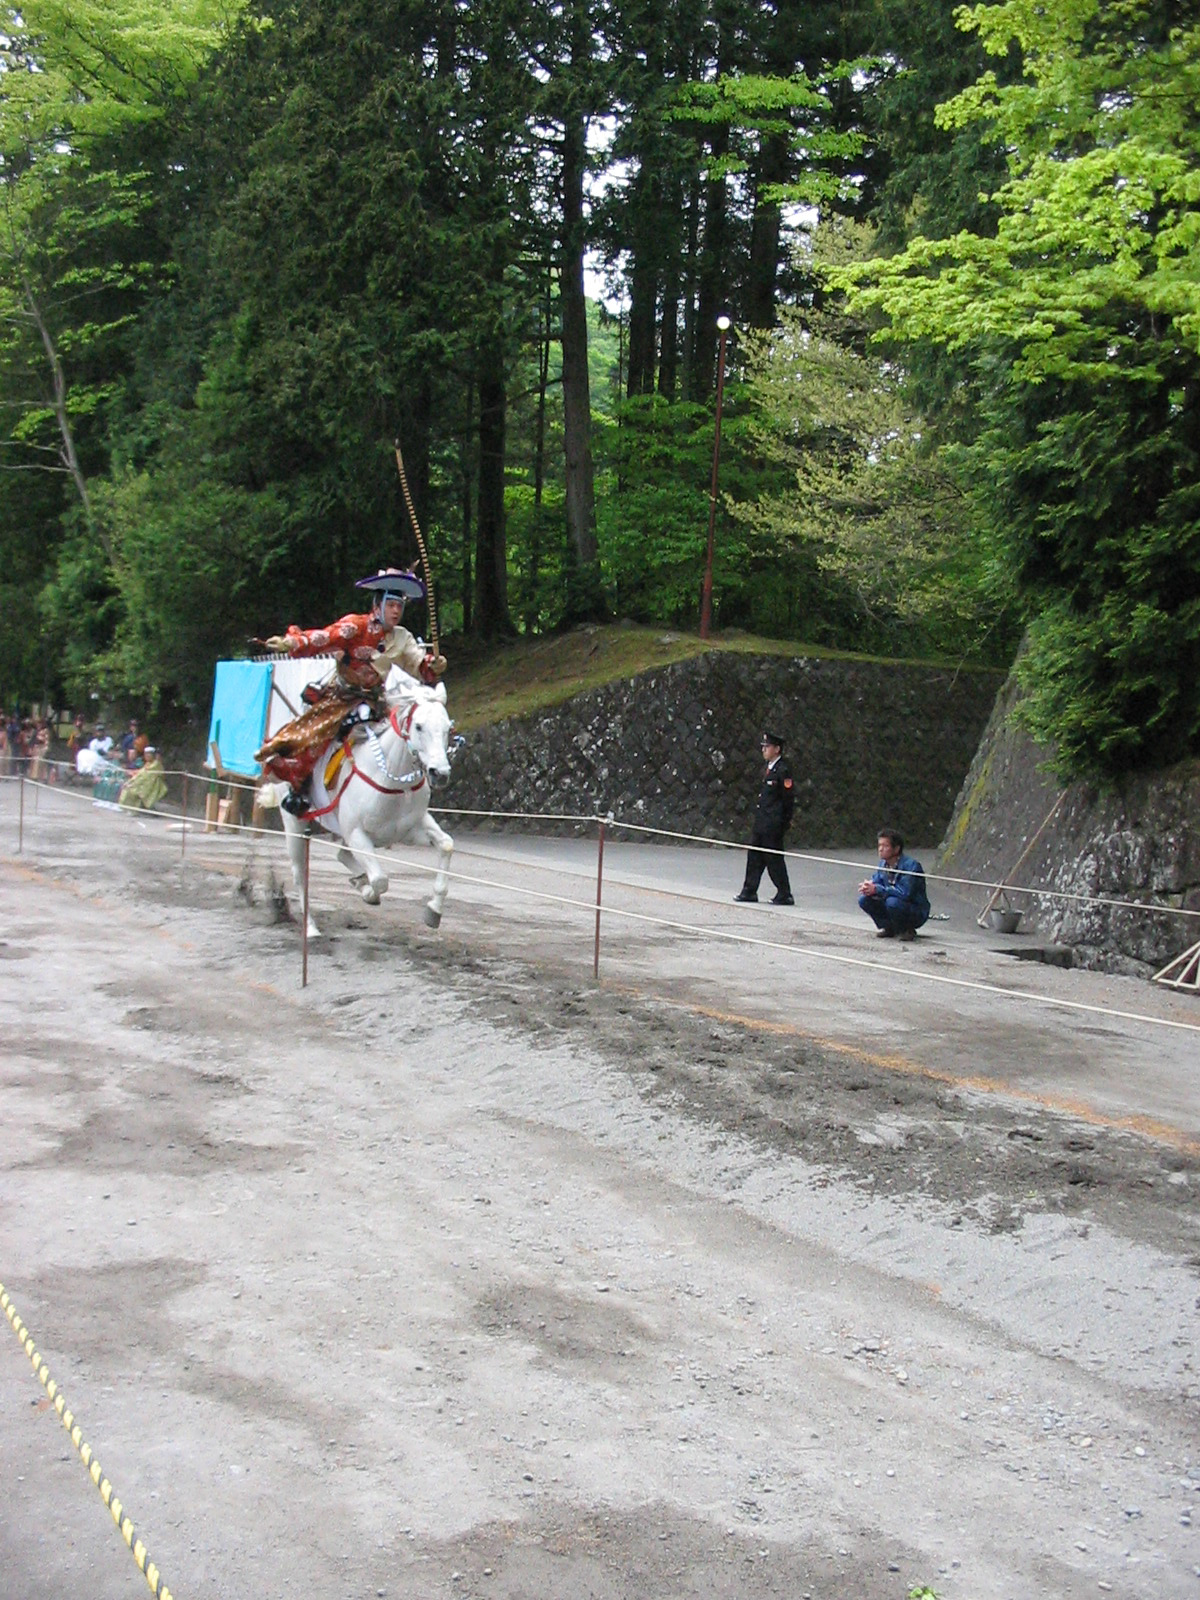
left=259, top=667, right=461, bottom=938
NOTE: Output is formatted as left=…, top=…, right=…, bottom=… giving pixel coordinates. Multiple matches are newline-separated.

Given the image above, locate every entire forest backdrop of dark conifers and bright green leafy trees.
left=0, top=0, right=1200, bottom=773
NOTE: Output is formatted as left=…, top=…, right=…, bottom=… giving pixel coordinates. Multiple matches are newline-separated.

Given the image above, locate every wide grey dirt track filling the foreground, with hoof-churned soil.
left=0, top=792, right=1200, bottom=1600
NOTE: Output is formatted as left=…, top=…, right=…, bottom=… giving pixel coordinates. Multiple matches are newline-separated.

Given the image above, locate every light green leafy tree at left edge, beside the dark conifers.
left=0, top=0, right=244, bottom=707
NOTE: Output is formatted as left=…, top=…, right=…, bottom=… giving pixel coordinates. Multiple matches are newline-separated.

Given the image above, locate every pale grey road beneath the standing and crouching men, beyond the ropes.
left=438, top=830, right=1200, bottom=1144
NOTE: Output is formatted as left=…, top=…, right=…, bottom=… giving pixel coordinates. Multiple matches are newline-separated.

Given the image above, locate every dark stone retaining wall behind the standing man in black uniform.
left=440, top=651, right=1002, bottom=850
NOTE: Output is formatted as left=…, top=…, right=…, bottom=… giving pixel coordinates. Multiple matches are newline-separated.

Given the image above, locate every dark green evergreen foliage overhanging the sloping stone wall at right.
left=965, top=369, right=1200, bottom=778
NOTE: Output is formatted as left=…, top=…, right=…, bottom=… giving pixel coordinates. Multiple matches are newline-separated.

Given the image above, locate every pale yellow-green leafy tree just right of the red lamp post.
left=731, top=222, right=1006, bottom=654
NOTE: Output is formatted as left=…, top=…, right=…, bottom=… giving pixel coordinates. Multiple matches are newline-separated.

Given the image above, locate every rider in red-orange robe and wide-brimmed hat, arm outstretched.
left=254, top=566, right=446, bottom=816
